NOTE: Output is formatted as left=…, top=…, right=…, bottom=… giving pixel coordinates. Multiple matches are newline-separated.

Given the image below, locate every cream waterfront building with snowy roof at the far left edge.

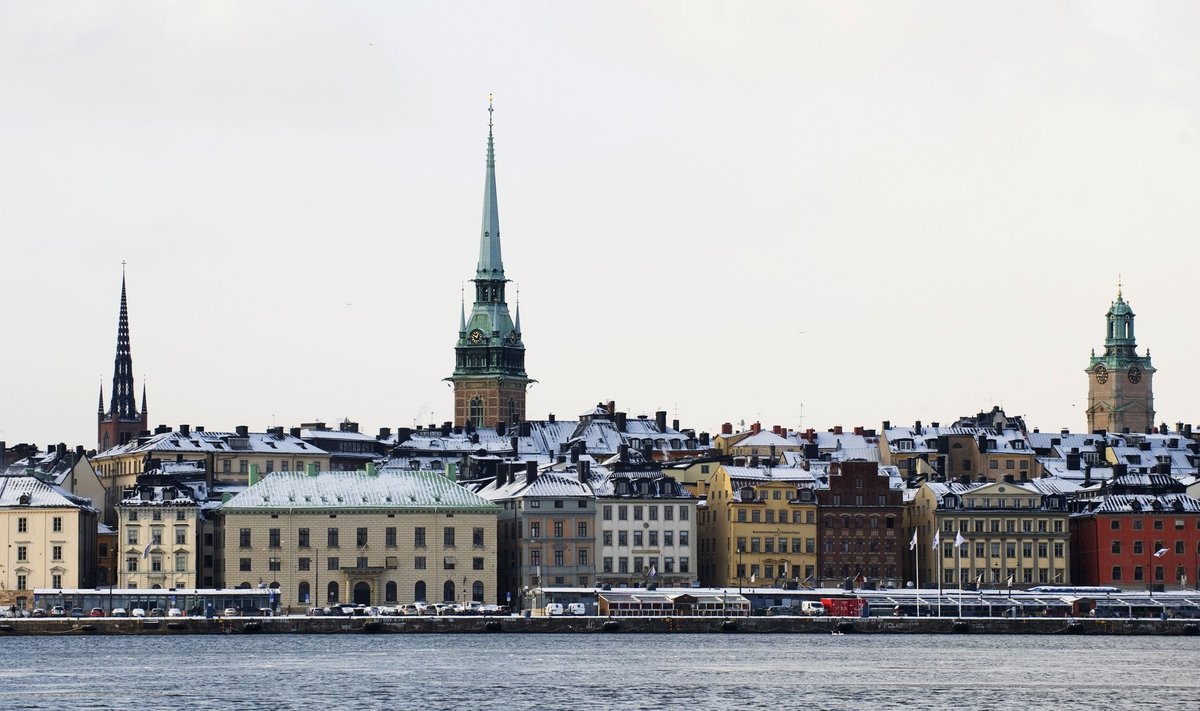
left=0, top=476, right=98, bottom=608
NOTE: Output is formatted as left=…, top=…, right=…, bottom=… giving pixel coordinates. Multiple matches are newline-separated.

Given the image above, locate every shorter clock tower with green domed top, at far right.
left=1085, top=287, right=1154, bottom=434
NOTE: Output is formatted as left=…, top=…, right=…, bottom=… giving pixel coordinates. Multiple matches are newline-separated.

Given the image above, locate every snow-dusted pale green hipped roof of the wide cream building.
left=221, top=470, right=496, bottom=513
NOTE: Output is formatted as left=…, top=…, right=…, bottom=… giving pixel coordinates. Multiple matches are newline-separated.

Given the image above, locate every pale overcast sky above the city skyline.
left=0, top=0, right=1200, bottom=447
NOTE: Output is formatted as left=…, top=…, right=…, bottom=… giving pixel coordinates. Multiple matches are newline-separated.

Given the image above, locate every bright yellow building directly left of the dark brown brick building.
left=696, top=465, right=817, bottom=587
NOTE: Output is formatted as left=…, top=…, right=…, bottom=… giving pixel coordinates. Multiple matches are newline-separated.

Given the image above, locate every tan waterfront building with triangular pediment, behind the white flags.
left=907, top=478, right=1072, bottom=588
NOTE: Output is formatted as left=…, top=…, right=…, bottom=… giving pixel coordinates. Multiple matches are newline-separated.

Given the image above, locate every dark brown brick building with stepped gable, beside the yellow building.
left=816, top=461, right=908, bottom=588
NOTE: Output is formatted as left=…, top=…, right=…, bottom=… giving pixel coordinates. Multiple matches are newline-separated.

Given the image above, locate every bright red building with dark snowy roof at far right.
left=1070, top=473, right=1200, bottom=590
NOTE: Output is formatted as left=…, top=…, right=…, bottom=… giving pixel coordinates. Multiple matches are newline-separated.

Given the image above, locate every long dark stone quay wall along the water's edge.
left=0, top=616, right=1200, bottom=638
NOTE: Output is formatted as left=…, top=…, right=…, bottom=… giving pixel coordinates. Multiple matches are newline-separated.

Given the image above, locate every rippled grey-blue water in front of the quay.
left=0, top=634, right=1200, bottom=711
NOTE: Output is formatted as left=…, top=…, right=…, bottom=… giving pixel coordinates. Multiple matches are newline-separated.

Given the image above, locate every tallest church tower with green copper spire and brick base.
left=445, top=98, right=534, bottom=428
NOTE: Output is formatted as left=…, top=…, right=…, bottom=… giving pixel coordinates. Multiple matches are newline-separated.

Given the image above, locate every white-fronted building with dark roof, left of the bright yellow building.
left=592, top=455, right=698, bottom=587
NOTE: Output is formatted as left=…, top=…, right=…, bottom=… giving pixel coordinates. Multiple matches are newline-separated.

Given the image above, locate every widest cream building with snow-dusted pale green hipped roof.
left=218, top=466, right=500, bottom=611
